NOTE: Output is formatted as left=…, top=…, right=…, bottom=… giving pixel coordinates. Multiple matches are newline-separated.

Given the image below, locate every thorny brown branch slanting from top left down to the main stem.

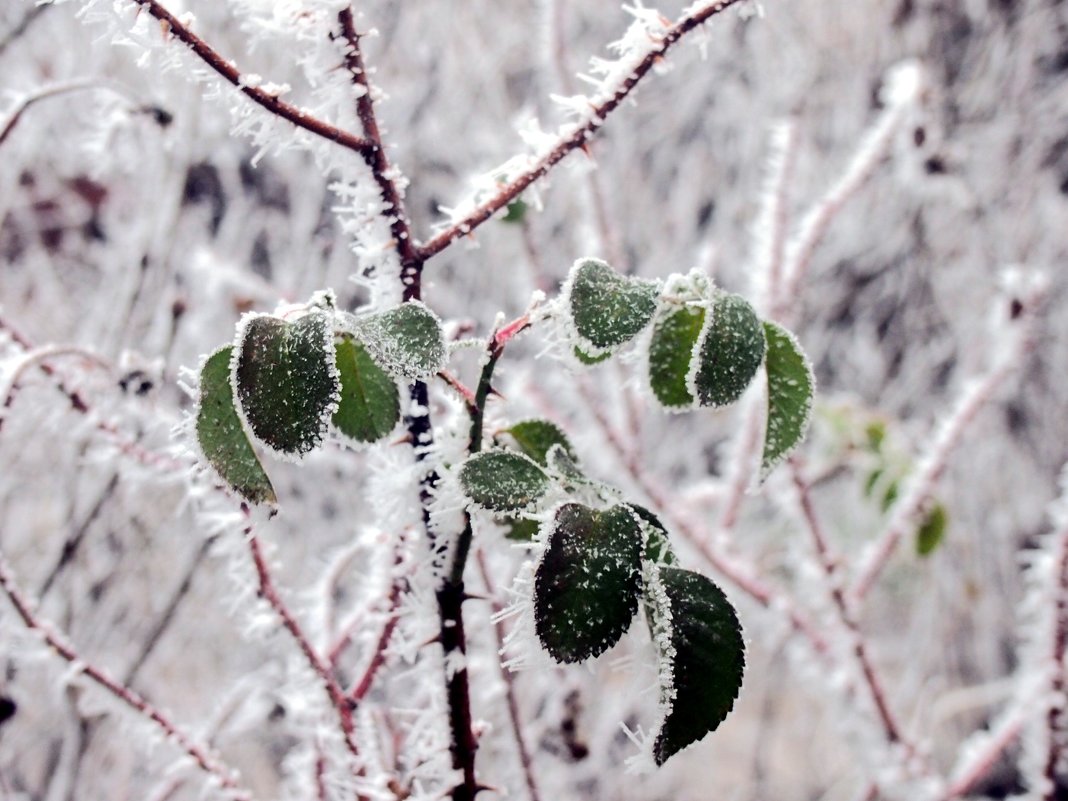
left=130, top=0, right=374, bottom=156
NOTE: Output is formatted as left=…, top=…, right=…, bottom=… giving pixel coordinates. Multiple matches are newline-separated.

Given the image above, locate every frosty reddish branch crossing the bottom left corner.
left=0, top=553, right=252, bottom=801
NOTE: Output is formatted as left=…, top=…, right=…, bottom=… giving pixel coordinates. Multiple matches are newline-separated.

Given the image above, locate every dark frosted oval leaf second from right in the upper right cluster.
left=693, top=293, right=766, bottom=407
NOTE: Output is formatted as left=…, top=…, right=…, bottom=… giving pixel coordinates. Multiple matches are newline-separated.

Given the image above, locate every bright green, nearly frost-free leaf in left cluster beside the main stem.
left=333, top=336, right=401, bottom=442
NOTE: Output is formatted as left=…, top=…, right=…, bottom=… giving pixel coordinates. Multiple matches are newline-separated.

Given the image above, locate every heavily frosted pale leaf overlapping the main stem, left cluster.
left=352, top=300, right=449, bottom=382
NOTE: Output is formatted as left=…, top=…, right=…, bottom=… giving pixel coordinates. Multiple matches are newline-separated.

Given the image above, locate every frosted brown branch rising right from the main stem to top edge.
left=415, top=0, right=741, bottom=261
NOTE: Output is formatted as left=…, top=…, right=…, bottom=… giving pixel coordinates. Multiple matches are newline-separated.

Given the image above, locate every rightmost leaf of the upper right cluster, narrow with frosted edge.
left=760, top=321, right=816, bottom=478
